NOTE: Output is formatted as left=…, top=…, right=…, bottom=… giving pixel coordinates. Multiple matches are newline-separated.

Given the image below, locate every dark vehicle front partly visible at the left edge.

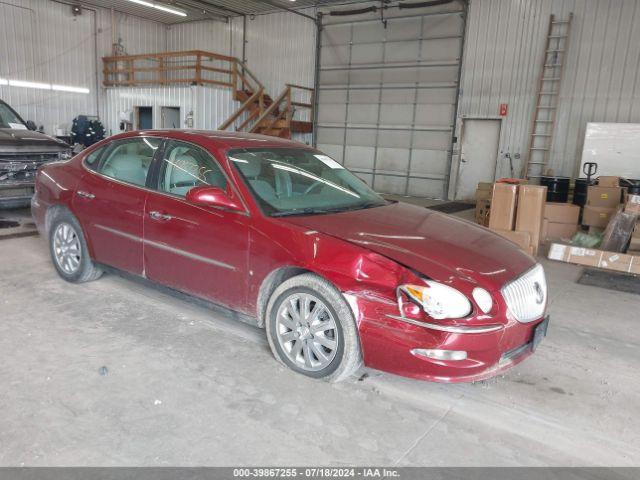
left=0, top=100, right=72, bottom=209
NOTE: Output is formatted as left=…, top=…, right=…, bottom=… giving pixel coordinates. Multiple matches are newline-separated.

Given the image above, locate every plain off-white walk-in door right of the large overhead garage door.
left=456, top=118, right=501, bottom=200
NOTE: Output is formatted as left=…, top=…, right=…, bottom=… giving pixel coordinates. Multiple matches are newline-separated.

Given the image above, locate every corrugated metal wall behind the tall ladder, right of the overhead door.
left=458, top=0, right=640, bottom=187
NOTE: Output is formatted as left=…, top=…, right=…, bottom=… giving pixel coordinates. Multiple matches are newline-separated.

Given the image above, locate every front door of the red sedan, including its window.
left=144, top=140, right=249, bottom=311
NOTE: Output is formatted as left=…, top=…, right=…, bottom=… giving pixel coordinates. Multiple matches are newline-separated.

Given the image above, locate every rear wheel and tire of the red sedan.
left=49, top=210, right=102, bottom=283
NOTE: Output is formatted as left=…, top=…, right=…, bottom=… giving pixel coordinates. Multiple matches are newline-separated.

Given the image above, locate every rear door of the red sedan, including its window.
left=73, top=137, right=162, bottom=275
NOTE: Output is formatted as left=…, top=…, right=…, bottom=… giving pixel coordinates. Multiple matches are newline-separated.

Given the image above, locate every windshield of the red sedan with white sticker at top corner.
left=227, top=148, right=386, bottom=217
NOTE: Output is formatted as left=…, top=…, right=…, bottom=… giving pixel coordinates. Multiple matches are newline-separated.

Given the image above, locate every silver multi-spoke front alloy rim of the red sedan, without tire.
left=276, top=292, right=340, bottom=372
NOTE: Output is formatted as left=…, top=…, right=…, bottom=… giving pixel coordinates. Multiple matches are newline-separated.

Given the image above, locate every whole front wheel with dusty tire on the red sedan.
left=265, top=273, right=362, bottom=382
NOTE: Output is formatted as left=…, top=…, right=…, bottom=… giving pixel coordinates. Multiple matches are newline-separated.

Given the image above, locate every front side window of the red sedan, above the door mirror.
left=158, top=141, right=227, bottom=197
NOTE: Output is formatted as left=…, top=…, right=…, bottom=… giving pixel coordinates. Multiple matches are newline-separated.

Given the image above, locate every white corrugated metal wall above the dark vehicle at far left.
left=0, top=0, right=98, bottom=132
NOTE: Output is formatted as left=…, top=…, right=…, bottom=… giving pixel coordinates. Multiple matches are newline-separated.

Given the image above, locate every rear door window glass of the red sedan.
left=99, top=137, right=162, bottom=187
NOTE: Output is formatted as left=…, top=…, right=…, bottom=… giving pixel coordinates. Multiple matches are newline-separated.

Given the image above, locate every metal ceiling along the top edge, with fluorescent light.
left=74, top=0, right=356, bottom=24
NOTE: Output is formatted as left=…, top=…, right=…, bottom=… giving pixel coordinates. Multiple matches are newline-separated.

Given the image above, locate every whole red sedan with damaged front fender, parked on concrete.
left=32, top=130, right=548, bottom=382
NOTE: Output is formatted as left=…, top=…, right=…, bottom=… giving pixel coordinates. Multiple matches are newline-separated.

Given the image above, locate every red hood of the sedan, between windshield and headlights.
left=283, top=203, right=535, bottom=290
